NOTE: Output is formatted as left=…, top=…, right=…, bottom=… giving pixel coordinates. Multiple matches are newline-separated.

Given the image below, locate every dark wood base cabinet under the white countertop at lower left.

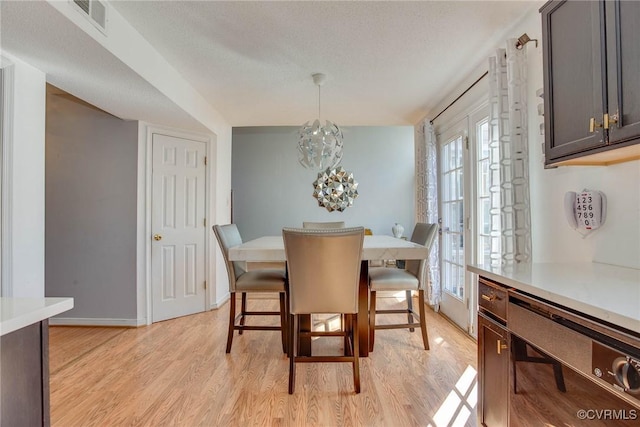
left=0, top=320, right=50, bottom=427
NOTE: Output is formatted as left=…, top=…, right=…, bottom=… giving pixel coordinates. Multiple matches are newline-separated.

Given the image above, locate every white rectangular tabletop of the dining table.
left=229, top=235, right=429, bottom=261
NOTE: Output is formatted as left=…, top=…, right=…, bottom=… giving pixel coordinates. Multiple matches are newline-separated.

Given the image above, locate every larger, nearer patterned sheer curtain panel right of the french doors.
left=489, top=39, right=531, bottom=264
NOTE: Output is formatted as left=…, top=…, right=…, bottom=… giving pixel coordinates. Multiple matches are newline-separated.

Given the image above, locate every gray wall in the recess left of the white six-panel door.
left=45, top=88, right=138, bottom=319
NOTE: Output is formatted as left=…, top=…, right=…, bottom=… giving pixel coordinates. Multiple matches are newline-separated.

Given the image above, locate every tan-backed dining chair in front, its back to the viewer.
left=282, top=227, right=364, bottom=394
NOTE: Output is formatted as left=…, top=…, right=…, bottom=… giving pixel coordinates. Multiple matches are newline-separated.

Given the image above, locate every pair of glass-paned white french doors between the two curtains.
left=438, top=104, right=491, bottom=335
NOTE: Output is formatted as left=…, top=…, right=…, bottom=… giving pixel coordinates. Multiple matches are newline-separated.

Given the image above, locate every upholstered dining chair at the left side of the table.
left=213, top=224, right=287, bottom=353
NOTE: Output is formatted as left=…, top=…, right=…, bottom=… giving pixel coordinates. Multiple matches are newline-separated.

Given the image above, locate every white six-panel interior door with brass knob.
left=149, top=134, right=206, bottom=322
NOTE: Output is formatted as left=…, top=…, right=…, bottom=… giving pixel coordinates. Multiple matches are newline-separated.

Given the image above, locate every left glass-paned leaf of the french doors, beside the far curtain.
left=439, top=118, right=471, bottom=331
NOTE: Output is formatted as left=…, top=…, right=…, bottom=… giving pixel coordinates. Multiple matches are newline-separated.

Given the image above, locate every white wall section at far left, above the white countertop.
left=2, top=53, right=46, bottom=297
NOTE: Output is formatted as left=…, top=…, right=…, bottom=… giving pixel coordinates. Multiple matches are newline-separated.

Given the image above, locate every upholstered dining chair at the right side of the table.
left=369, top=223, right=438, bottom=351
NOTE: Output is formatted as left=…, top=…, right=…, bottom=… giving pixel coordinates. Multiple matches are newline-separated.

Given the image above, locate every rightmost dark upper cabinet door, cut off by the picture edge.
left=605, top=0, right=640, bottom=144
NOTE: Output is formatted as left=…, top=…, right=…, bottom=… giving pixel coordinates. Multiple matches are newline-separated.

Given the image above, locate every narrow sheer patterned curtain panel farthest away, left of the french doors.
left=415, top=120, right=441, bottom=311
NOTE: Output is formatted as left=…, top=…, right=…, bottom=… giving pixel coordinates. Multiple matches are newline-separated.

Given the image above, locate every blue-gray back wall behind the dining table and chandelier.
left=231, top=126, right=415, bottom=240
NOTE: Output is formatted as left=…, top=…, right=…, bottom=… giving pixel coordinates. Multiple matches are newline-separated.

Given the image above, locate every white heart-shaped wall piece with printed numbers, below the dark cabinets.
left=564, top=189, right=607, bottom=237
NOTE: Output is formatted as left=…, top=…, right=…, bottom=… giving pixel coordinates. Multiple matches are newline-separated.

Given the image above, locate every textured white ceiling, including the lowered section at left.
left=1, top=0, right=541, bottom=126
